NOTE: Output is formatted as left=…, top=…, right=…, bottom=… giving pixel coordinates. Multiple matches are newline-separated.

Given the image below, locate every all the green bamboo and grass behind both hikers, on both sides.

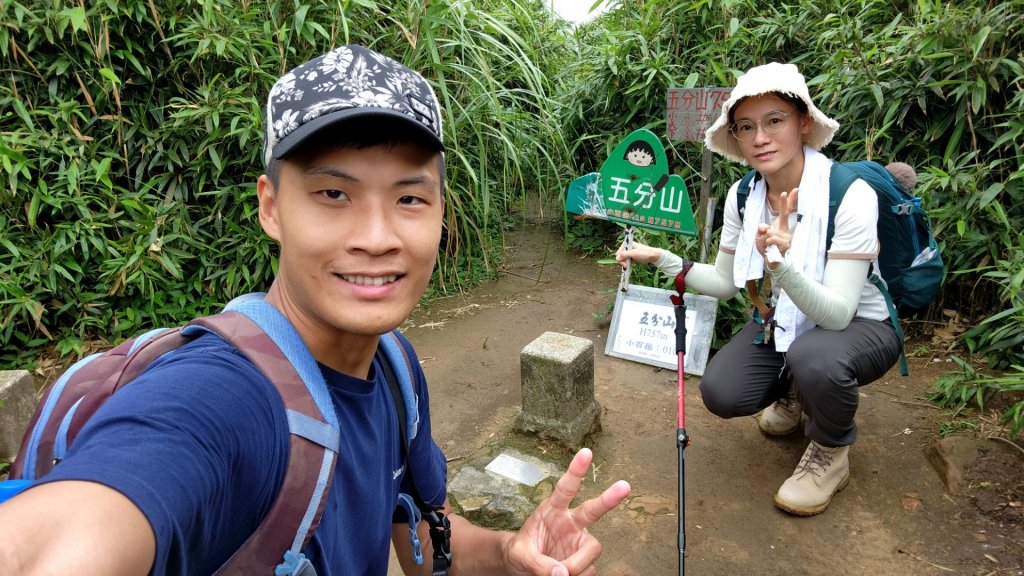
left=0, top=0, right=1024, bottom=429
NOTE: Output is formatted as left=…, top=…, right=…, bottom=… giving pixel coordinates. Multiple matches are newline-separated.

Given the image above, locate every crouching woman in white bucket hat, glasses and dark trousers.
left=616, top=63, right=903, bottom=516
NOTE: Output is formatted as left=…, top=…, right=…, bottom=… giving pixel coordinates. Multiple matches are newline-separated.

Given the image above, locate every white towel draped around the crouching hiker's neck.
left=732, top=147, right=833, bottom=352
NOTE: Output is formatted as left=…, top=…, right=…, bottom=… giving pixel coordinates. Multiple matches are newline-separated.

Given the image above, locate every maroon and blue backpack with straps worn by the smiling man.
left=0, top=294, right=451, bottom=576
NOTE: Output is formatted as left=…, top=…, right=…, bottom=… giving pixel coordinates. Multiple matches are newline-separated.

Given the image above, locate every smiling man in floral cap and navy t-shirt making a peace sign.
left=0, top=46, right=630, bottom=576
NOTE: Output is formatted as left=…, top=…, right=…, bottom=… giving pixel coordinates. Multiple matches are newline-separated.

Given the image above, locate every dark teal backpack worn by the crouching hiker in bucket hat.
left=736, top=160, right=943, bottom=375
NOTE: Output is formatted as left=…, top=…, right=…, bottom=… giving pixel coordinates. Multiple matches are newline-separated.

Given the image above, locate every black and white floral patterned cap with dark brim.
left=263, top=45, right=444, bottom=164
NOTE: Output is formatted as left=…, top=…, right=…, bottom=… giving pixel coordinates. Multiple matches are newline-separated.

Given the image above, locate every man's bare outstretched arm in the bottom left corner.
left=0, top=481, right=156, bottom=576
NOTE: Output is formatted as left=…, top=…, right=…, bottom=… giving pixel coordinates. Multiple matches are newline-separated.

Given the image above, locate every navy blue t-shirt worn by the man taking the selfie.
left=43, top=335, right=446, bottom=576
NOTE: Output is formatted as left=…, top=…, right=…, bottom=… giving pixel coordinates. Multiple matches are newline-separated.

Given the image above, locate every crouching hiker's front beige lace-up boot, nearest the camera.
left=775, top=441, right=850, bottom=516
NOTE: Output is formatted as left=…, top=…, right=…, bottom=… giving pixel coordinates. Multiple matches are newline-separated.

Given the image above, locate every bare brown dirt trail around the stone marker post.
left=394, top=225, right=1024, bottom=576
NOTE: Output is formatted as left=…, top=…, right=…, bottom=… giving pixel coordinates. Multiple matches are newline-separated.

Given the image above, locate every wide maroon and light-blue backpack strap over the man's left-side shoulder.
left=191, top=294, right=340, bottom=576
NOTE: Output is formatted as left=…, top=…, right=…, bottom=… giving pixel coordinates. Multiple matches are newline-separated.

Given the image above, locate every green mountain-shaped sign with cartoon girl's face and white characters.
left=565, top=129, right=697, bottom=237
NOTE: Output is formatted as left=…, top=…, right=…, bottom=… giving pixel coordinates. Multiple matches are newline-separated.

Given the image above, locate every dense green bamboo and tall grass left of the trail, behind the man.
left=0, top=0, right=568, bottom=365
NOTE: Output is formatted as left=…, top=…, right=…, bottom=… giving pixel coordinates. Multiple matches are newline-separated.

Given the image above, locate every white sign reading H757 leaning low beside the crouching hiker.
left=604, top=285, right=718, bottom=376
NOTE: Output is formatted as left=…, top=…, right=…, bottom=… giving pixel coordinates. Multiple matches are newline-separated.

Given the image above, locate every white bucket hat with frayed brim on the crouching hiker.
left=705, top=63, right=839, bottom=164
